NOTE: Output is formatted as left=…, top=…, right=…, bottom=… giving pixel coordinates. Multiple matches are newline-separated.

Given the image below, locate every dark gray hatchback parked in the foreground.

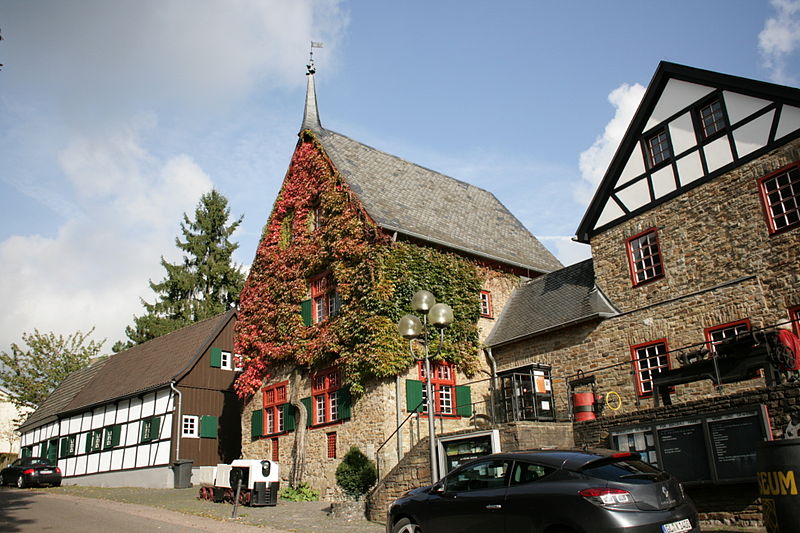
left=386, top=450, right=700, bottom=533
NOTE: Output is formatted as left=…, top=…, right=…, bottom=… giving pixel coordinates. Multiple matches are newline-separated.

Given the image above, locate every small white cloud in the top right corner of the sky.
left=758, top=0, right=800, bottom=85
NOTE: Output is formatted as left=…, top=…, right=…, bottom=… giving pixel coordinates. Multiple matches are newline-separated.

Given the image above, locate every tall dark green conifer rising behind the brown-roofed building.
left=114, top=190, right=244, bottom=352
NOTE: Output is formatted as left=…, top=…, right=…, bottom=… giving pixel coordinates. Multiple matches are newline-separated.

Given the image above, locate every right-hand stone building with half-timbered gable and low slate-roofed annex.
left=487, top=63, right=800, bottom=522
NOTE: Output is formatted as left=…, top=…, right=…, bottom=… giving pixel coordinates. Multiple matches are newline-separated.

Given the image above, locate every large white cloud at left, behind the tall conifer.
left=0, top=122, right=212, bottom=348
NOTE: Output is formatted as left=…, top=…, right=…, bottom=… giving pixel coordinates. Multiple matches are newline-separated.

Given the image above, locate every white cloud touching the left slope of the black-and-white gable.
left=575, top=83, right=645, bottom=205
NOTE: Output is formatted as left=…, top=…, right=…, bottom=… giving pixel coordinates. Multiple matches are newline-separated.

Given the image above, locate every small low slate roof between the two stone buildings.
left=485, top=259, right=619, bottom=347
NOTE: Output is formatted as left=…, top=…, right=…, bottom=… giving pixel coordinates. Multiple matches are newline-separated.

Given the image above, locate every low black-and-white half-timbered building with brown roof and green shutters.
left=19, top=311, right=241, bottom=487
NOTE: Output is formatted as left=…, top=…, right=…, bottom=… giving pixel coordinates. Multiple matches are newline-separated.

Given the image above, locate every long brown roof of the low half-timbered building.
left=19, top=310, right=236, bottom=431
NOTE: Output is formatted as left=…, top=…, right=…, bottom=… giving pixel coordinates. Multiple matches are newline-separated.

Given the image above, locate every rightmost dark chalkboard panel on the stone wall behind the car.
left=708, top=413, right=764, bottom=479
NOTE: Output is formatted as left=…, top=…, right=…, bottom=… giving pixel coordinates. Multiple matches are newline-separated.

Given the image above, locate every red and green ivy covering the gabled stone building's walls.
left=235, top=132, right=482, bottom=398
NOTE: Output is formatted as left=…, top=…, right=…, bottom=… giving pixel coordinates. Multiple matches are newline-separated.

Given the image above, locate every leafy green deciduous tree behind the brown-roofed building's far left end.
left=0, top=328, right=105, bottom=409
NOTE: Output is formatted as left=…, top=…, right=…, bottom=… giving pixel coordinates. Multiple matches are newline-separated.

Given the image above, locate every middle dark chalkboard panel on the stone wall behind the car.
left=656, top=420, right=711, bottom=481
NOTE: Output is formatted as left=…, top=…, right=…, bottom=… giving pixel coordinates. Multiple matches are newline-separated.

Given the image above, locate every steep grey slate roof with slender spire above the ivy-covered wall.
left=301, top=73, right=562, bottom=273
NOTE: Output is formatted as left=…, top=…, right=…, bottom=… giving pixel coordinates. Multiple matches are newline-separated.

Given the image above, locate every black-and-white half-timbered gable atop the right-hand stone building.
left=577, top=61, right=800, bottom=243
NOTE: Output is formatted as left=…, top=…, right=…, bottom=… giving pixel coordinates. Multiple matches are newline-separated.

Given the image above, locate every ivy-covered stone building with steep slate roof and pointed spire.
left=236, top=64, right=561, bottom=498
